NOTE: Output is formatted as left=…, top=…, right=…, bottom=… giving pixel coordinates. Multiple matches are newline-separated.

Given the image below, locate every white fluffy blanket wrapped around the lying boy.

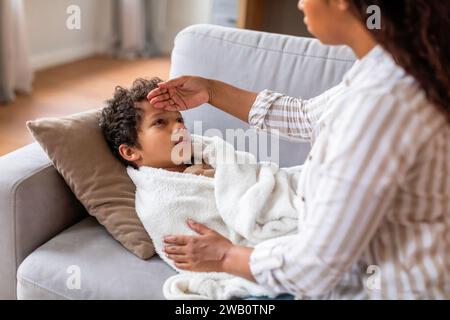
left=128, top=135, right=301, bottom=299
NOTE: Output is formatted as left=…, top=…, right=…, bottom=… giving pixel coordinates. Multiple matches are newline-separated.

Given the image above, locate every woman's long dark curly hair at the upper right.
left=350, top=0, right=450, bottom=124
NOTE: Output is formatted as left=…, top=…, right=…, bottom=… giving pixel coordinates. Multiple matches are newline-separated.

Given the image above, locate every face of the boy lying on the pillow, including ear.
left=120, top=101, right=191, bottom=170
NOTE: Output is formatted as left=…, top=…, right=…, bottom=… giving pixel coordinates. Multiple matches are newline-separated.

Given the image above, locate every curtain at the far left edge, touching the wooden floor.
left=0, top=0, right=33, bottom=102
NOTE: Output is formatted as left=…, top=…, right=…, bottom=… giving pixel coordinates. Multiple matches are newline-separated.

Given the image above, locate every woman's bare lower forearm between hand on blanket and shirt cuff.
left=222, top=245, right=256, bottom=282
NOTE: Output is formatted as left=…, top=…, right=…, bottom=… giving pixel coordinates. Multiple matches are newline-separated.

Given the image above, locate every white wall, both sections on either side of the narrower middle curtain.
left=24, top=0, right=212, bottom=69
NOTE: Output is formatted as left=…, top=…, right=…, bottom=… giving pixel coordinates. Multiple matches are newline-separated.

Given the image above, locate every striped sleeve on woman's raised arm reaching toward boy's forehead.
left=249, top=83, right=344, bottom=142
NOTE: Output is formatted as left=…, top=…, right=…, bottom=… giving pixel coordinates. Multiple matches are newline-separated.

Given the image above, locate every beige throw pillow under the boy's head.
left=27, top=110, right=155, bottom=259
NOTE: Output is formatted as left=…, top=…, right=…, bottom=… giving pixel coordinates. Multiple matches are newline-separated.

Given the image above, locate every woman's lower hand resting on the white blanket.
left=164, top=220, right=234, bottom=272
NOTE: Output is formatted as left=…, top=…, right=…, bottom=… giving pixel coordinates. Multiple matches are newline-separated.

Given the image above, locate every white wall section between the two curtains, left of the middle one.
left=24, top=0, right=112, bottom=69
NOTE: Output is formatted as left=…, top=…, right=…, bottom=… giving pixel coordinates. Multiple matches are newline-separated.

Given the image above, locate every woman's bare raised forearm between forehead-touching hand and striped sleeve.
left=209, top=80, right=258, bottom=122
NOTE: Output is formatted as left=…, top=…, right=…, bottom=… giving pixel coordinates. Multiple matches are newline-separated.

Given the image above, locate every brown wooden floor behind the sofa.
left=0, top=57, right=170, bottom=156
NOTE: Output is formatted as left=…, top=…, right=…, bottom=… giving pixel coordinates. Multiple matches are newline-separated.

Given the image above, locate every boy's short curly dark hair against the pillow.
left=99, top=78, right=162, bottom=168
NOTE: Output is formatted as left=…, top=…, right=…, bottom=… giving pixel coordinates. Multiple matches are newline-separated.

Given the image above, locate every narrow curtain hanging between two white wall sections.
left=112, top=0, right=159, bottom=59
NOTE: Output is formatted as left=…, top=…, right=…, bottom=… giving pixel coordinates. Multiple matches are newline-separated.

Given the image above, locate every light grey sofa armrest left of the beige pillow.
left=0, top=143, right=86, bottom=299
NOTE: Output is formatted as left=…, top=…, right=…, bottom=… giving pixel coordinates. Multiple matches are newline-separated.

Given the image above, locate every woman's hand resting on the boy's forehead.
left=147, top=76, right=212, bottom=111
